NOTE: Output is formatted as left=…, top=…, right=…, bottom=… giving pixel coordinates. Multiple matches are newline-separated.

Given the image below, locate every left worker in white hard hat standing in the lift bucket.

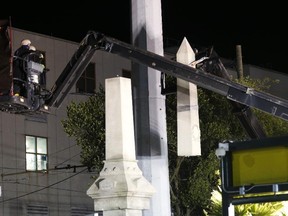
left=12, top=39, right=35, bottom=96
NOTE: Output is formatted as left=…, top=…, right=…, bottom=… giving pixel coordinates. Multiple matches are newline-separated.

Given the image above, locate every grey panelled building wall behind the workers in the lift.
left=0, top=29, right=130, bottom=216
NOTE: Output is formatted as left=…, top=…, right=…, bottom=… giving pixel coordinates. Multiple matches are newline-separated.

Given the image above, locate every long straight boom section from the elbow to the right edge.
left=95, top=33, right=288, bottom=121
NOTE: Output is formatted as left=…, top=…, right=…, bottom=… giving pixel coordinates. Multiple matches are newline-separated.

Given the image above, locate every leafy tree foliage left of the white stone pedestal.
left=62, top=86, right=105, bottom=170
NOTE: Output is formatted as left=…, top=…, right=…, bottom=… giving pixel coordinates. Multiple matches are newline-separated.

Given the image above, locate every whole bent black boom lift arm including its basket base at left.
left=0, top=31, right=288, bottom=136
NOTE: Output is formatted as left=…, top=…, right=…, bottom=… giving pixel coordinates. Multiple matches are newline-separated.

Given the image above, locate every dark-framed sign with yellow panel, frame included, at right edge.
left=216, top=136, right=288, bottom=195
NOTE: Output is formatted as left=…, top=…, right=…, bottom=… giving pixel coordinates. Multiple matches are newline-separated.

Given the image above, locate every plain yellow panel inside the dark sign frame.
left=232, top=146, right=288, bottom=187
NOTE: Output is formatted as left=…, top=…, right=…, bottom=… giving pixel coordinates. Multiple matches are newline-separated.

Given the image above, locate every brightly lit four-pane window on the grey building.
left=26, top=136, right=47, bottom=171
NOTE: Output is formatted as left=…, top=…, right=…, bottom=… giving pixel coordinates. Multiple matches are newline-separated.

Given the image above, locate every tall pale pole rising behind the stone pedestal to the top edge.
left=131, top=0, right=171, bottom=216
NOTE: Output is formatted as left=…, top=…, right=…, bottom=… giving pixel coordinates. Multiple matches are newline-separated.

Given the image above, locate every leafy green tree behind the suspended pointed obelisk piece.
left=166, top=77, right=246, bottom=215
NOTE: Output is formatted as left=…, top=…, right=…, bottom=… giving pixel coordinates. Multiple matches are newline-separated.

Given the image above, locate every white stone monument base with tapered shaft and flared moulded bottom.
left=87, top=77, right=155, bottom=216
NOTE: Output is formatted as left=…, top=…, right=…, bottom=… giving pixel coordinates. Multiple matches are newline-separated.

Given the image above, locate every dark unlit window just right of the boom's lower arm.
left=76, top=63, right=96, bottom=93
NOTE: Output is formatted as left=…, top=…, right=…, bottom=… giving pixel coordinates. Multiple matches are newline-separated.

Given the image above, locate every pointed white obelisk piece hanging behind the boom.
left=176, top=38, right=201, bottom=156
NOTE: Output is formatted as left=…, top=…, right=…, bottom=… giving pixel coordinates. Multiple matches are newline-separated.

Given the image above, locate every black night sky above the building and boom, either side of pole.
left=2, top=0, right=288, bottom=73
